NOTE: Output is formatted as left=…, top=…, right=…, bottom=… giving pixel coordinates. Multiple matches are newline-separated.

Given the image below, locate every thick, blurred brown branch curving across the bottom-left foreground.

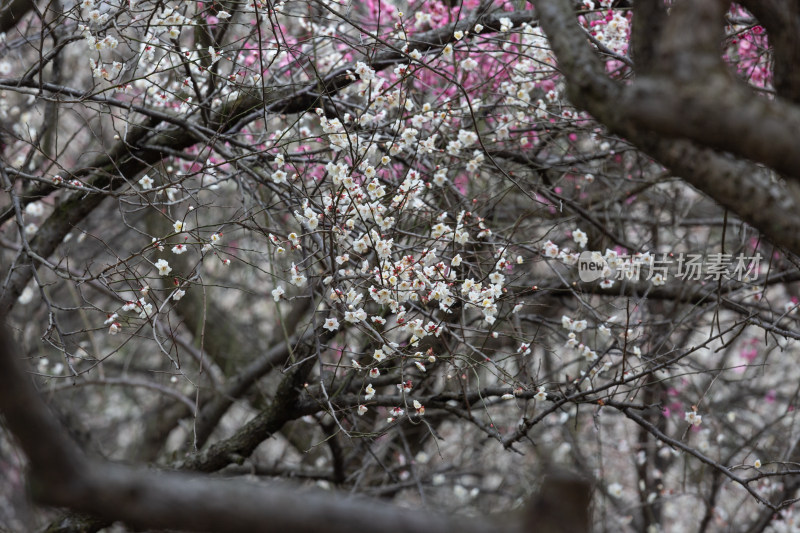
left=0, top=316, right=510, bottom=533
